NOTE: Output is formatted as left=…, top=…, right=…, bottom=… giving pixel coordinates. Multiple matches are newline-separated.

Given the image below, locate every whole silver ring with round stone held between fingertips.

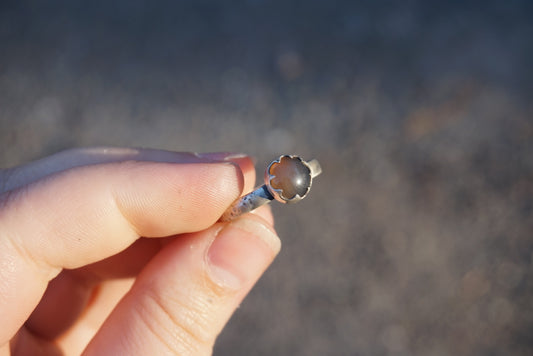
left=220, top=155, right=322, bottom=221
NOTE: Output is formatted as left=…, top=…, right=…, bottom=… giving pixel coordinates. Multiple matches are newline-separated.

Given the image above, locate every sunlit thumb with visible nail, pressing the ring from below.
left=85, top=214, right=280, bottom=355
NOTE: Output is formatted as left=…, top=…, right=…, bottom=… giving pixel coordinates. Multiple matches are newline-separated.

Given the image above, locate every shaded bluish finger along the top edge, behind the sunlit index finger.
left=0, top=147, right=255, bottom=192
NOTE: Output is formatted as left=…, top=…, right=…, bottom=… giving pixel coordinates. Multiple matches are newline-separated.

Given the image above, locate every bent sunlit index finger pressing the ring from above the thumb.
left=0, top=162, right=243, bottom=344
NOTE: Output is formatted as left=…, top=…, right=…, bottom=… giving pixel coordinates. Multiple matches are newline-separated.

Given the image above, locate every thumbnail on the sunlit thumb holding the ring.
left=207, top=216, right=281, bottom=290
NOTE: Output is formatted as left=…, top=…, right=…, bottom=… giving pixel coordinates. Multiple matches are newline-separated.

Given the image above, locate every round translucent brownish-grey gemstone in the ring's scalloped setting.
left=268, top=156, right=311, bottom=201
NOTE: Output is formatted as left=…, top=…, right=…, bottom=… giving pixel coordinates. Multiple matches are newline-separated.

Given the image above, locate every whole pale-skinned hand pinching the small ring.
left=0, top=148, right=280, bottom=356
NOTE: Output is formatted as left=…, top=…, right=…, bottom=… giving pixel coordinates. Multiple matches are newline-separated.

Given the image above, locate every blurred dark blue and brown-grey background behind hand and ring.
left=0, top=0, right=533, bottom=356
